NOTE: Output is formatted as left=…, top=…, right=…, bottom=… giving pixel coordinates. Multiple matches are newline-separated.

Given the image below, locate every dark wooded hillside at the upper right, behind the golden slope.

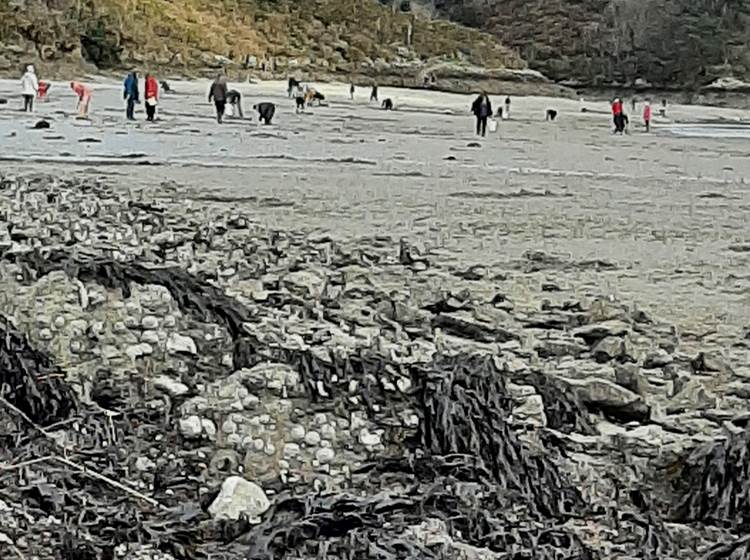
left=424, top=0, right=750, bottom=87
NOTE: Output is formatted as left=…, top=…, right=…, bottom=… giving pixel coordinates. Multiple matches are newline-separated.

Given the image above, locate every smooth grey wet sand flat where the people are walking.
left=0, top=77, right=750, bottom=338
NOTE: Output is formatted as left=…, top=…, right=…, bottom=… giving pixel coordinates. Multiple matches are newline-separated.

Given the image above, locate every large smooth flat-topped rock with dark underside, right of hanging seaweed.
left=566, top=378, right=651, bottom=422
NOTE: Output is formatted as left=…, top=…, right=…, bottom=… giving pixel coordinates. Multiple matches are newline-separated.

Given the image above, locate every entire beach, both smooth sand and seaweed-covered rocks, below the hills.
left=0, top=80, right=750, bottom=560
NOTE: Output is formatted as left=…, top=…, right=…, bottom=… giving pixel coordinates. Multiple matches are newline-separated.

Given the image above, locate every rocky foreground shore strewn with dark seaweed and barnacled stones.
left=0, top=175, right=750, bottom=560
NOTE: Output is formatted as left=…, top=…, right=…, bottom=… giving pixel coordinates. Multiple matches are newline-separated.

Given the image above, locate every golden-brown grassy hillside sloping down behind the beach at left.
left=0, top=0, right=526, bottom=82
